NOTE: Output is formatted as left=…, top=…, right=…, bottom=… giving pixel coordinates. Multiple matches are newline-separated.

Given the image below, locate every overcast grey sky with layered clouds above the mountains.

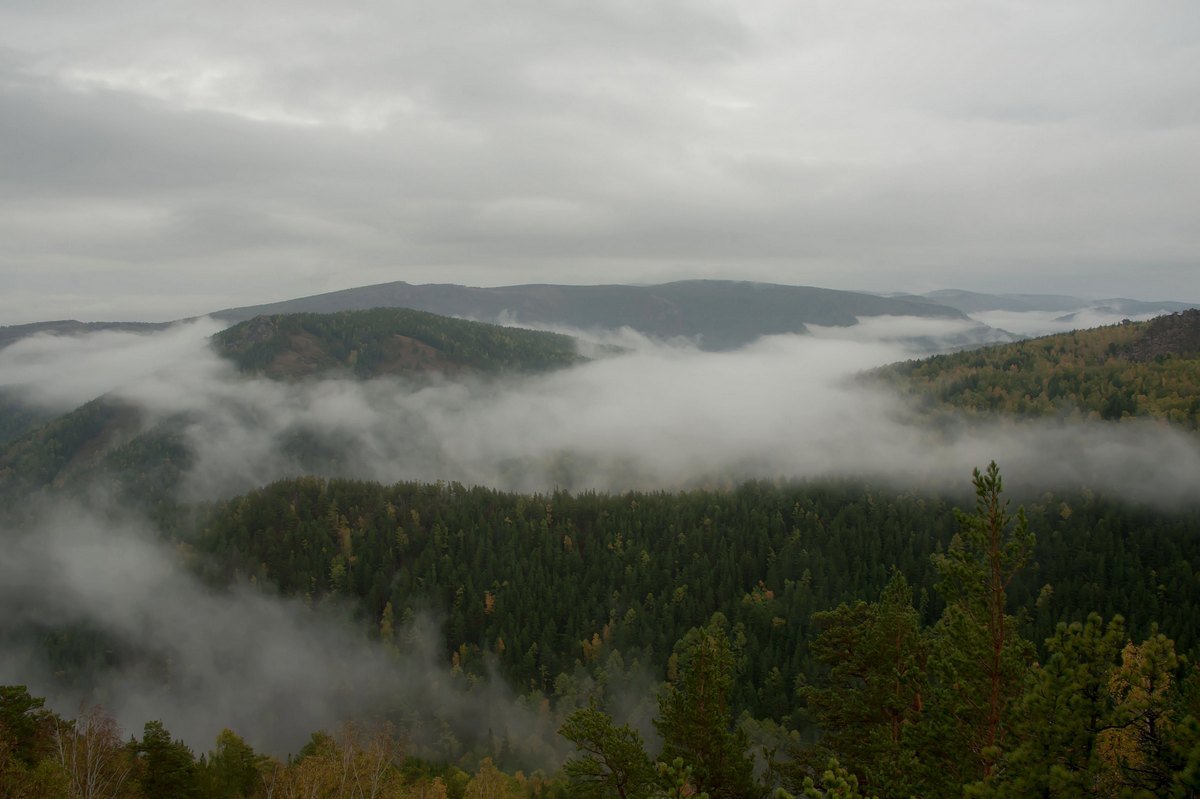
left=0, top=0, right=1200, bottom=324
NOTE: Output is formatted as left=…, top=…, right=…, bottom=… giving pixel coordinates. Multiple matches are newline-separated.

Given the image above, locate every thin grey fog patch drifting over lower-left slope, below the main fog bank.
left=0, top=506, right=563, bottom=763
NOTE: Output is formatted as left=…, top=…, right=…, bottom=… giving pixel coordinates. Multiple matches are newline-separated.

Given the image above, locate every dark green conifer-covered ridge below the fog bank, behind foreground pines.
left=193, top=477, right=1200, bottom=721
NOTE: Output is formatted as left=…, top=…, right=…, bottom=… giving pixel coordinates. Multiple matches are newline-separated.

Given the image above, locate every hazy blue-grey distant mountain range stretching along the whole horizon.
left=0, top=281, right=1200, bottom=350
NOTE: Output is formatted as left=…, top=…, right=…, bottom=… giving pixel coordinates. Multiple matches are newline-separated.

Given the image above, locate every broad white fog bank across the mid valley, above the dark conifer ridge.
left=2, top=318, right=1200, bottom=503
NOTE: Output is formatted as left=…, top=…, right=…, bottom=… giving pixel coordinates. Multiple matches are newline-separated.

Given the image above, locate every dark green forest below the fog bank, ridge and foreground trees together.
left=9, top=468, right=1200, bottom=798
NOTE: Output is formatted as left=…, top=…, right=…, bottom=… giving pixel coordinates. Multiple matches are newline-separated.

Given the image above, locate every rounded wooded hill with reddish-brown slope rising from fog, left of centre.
left=214, top=308, right=584, bottom=378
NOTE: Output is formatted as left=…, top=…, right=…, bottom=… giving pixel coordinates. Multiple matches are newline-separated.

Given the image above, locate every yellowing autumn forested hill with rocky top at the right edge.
left=874, top=310, right=1200, bottom=429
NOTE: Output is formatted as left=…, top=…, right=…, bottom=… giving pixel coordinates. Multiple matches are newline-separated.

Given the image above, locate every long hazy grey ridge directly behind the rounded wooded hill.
left=212, top=281, right=965, bottom=350
